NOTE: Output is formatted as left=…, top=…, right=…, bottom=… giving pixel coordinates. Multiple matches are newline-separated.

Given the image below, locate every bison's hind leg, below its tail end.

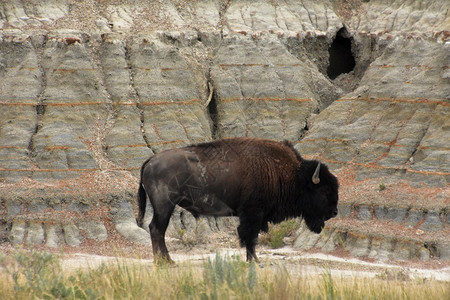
left=149, top=203, right=175, bottom=263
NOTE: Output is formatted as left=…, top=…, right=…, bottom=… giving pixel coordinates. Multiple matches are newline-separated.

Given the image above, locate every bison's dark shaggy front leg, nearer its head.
left=238, top=213, right=262, bottom=263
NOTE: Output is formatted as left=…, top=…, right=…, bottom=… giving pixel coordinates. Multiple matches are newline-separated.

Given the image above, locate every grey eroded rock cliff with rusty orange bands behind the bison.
left=0, top=0, right=450, bottom=259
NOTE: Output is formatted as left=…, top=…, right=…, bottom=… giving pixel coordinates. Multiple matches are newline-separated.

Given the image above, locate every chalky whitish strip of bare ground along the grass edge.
left=54, top=247, right=450, bottom=282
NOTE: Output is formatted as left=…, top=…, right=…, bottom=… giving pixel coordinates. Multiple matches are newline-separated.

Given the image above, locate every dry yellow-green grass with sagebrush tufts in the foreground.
left=0, top=252, right=450, bottom=300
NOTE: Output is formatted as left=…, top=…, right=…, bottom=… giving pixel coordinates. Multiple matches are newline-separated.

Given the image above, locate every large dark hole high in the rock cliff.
left=327, top=27, right=355, bottom=79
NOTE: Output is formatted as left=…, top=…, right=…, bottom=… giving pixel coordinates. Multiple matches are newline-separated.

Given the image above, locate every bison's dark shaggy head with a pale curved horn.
left=299, top=160, right=339, bottom=233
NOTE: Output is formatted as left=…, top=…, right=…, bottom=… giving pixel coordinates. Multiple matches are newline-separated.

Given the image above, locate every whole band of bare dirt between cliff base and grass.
left=0, top=227, right=450, bottom=282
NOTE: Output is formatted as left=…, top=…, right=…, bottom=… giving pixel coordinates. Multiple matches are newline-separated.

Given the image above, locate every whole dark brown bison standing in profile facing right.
left=137, top=138, right=339, bottom=262
